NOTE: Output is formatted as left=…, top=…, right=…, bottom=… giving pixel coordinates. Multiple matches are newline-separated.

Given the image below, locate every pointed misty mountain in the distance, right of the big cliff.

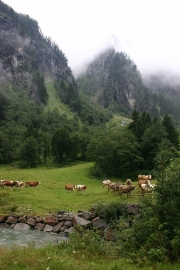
left=77, top=48, right=180, bottom=124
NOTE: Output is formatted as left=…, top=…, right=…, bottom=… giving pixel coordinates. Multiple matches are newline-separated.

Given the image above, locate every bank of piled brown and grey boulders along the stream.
left=0, top=204, right=139, bottom=240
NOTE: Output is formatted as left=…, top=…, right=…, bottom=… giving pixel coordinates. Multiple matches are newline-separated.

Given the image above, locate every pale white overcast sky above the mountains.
left=3, top=0, right=180, bottom=75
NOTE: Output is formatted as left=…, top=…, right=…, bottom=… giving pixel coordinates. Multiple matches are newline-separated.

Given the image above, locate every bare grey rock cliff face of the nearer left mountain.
left=0, top=13, right=74, bottom=103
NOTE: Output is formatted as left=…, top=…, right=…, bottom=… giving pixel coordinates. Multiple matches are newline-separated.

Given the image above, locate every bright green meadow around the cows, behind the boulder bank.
left=0, top=163, right=148, bottom=216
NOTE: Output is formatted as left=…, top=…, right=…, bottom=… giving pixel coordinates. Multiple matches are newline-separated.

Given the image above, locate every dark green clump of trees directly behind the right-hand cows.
left=87, top=110, right=179, bottom=177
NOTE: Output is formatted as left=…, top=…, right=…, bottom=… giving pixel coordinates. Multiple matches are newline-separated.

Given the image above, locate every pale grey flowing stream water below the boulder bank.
left=0, top=226, right=67, bottom=247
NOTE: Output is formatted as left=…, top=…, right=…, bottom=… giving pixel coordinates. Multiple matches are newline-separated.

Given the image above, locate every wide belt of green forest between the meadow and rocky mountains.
left=0, top=81, right=179, bottom=181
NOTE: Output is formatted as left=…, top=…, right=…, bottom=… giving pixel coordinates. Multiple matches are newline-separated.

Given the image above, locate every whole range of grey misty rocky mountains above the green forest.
left=0, top=1, right=180, bottom=126
